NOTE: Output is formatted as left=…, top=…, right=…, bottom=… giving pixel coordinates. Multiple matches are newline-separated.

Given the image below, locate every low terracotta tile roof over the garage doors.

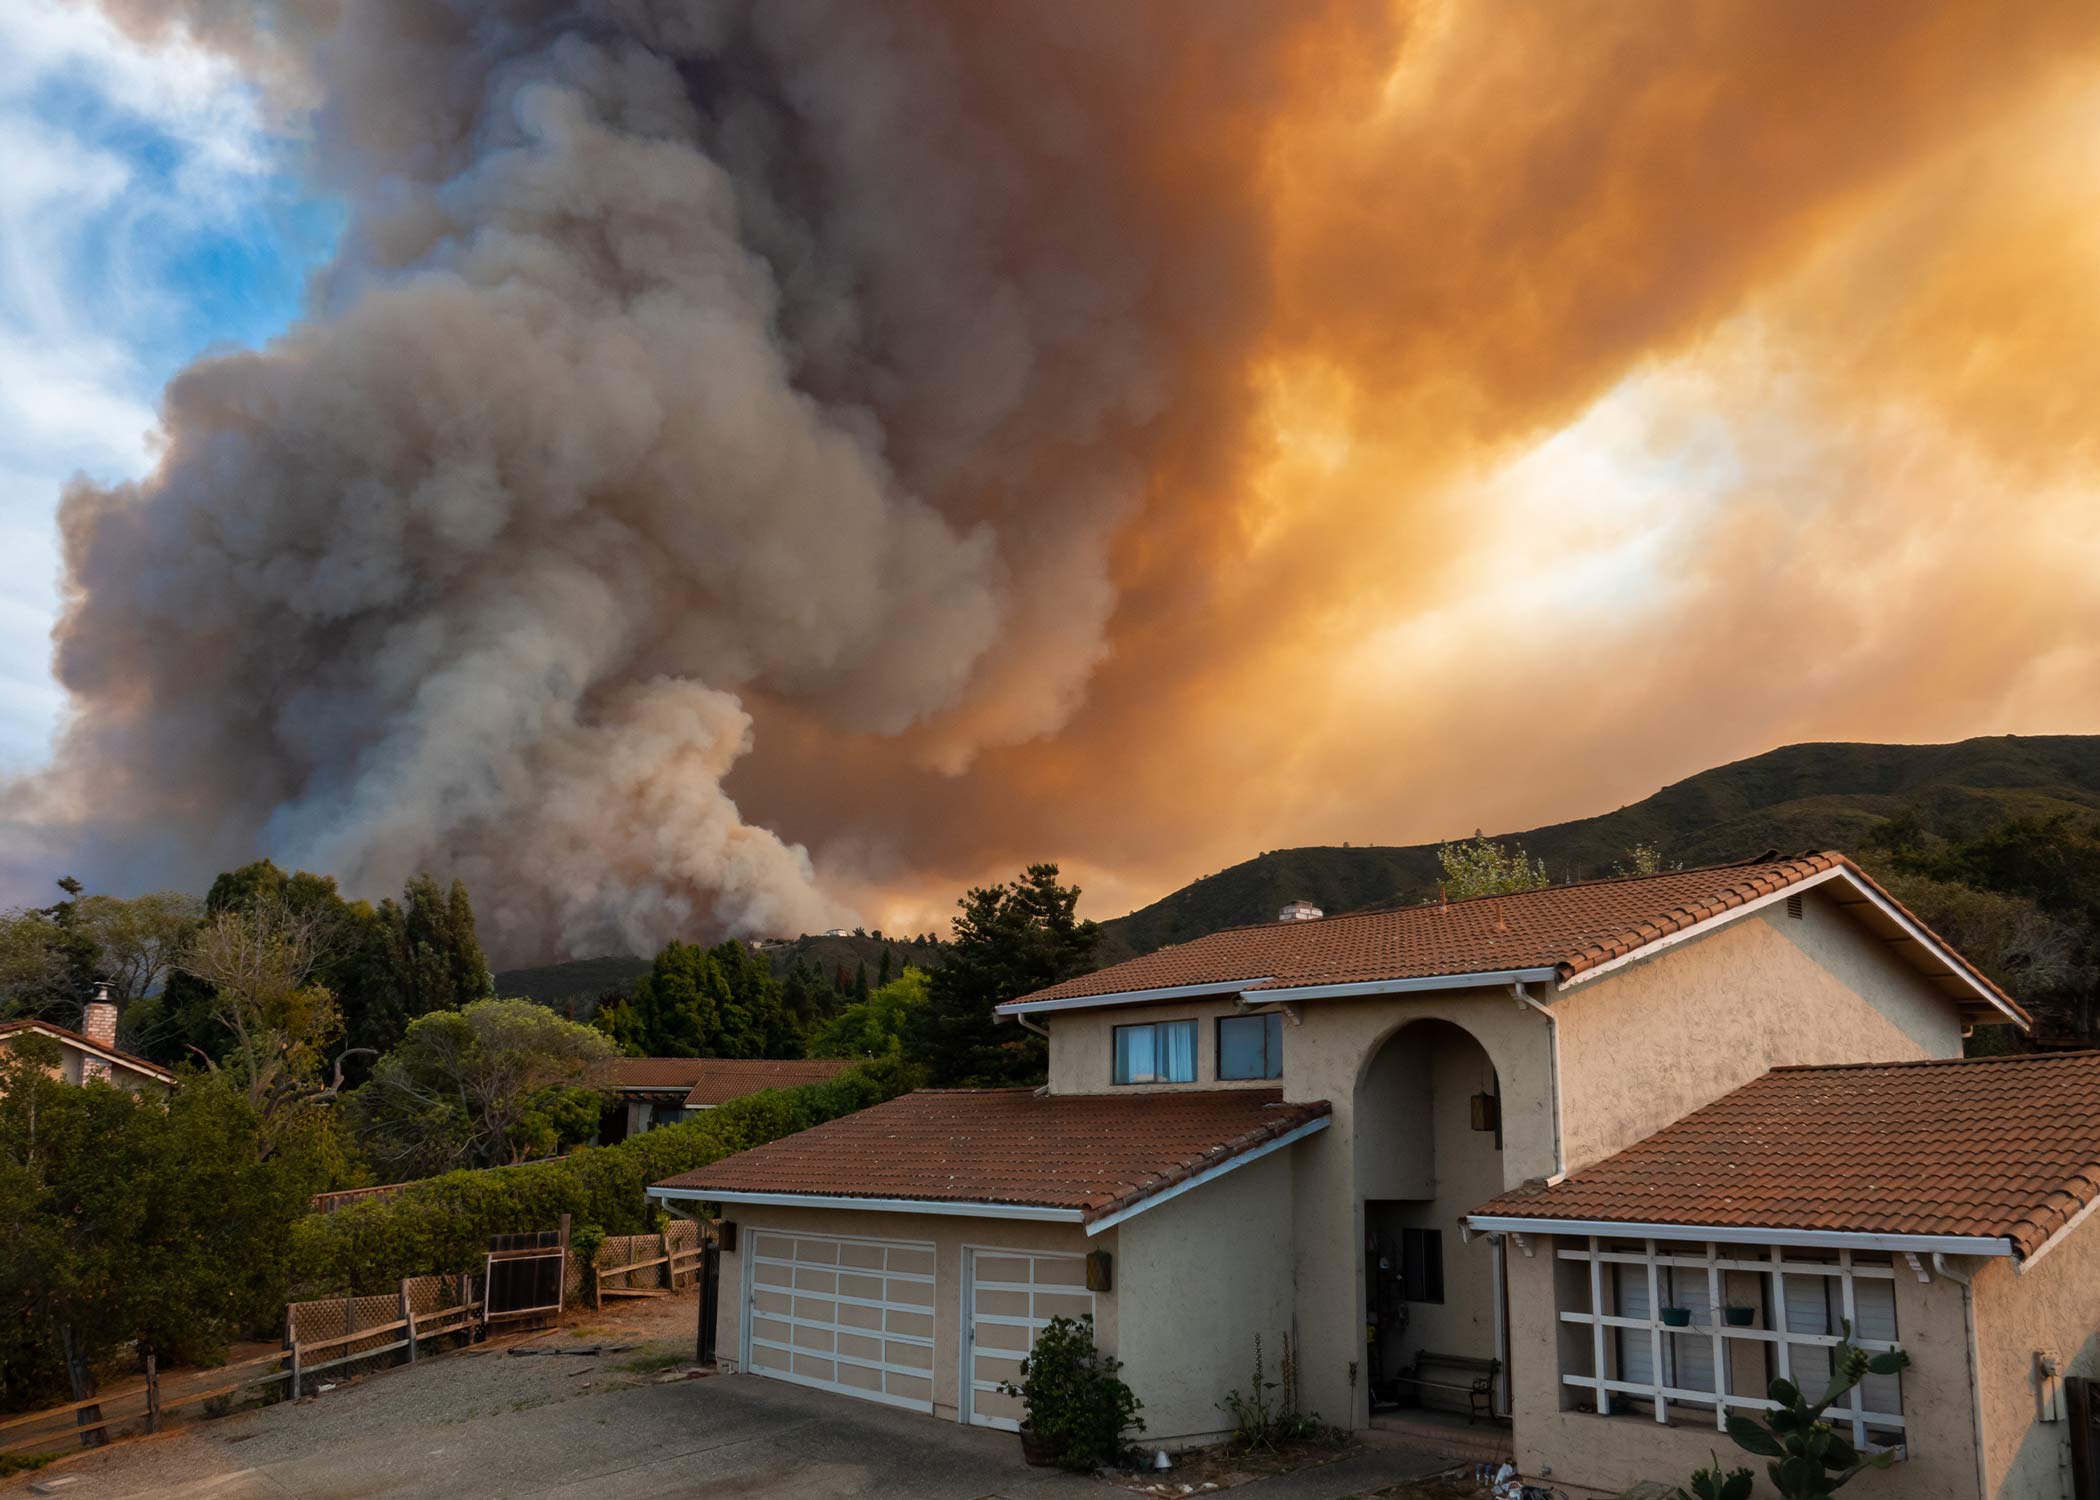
left=657, top=1088, right=1327, bottom=1223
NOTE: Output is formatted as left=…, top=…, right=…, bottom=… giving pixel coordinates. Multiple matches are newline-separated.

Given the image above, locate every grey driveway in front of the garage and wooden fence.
left=11, top=1353, right=1117, bottom=1500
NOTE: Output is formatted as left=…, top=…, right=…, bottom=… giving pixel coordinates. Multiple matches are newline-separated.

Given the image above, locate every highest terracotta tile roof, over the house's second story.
left=1000, top=853, right=2029, bottom=1025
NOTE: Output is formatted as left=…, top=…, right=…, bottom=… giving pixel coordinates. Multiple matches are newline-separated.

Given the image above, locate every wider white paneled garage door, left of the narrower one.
left=743, top=1229, right=932, bottom=1412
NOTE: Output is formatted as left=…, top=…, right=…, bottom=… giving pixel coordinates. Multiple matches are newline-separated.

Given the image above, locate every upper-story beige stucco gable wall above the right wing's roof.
left=1553, top=891, right=1961, bottom=1172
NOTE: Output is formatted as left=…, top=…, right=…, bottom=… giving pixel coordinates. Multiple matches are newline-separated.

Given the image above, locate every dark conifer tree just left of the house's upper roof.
left=905, top=863, right=1100, bottom=1086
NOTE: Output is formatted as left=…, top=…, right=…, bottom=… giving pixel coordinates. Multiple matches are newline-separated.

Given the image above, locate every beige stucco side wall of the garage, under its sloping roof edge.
left=1109, top=1137, right=1293, bottom=1447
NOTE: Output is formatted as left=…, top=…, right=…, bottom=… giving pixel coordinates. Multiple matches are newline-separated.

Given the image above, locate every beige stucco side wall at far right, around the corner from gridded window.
left=1974, top=1214, right=2100, bottom=1500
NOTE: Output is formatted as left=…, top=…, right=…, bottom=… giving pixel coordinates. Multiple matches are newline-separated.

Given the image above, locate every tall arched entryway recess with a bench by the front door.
left=1355, top=1019, right=1504, bottom=1410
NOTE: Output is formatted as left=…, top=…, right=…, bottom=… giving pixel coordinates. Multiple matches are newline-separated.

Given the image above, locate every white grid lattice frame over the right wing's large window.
left=1554, top=1235, right=1907, bottom=1456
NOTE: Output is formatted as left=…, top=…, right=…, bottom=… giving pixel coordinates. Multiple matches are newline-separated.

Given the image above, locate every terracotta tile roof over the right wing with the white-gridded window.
left=1474, top=1053, right=2100, bottom=1256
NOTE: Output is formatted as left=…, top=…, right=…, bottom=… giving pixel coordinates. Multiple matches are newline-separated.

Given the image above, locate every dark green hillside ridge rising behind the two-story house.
left=1100, top=735, right=2100, bottom=964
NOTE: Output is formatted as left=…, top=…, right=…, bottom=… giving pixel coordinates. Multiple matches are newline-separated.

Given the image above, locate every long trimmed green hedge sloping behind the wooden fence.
left=290, top=1061, right=916, bottom=1298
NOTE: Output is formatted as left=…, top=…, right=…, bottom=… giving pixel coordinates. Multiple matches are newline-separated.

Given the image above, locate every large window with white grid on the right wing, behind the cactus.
left=1554, top=1239, right=1905, bottom=1450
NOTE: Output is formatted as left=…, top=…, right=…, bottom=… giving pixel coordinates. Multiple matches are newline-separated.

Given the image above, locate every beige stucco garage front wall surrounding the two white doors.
left=716, top=1204, right=1121, bottom=1422
